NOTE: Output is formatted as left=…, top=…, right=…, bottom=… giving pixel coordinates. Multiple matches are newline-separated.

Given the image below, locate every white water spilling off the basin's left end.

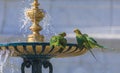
left=0, top=50, right=10, bottom=73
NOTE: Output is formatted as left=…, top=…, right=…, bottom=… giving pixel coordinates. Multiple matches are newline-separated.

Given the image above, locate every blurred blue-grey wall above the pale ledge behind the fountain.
left=0, top=0, right=120, bottom=35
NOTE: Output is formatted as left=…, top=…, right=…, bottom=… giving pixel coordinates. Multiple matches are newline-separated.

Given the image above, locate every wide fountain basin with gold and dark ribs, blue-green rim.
left=0, top=42, right=87, bottom=59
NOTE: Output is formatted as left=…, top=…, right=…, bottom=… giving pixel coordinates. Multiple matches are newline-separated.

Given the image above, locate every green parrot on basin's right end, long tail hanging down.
left=74, top=29, right=104, bottom=60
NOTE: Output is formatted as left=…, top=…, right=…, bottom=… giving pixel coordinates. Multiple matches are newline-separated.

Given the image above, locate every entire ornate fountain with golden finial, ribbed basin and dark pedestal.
left=0, top=0, right=104, bottom=73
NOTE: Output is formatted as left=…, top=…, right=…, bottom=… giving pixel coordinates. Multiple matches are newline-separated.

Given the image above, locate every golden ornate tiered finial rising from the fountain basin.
left=25, top=0, right=45, bottom=42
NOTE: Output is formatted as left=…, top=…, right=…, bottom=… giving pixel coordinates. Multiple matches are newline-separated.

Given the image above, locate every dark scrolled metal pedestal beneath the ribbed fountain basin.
left=21, top=57, right=53, bottom=73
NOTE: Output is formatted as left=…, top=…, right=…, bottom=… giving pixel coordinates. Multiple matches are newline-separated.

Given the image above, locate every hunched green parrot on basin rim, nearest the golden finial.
left=50, top=32, right=67, bottom=53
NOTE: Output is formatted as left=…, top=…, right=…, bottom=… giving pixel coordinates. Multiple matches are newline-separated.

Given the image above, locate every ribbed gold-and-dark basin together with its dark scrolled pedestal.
left=0, top=42, right=87, bottom=73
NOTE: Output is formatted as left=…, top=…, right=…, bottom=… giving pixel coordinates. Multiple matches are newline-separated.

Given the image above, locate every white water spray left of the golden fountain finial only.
left=20, top=0, right=32, bottom=38
